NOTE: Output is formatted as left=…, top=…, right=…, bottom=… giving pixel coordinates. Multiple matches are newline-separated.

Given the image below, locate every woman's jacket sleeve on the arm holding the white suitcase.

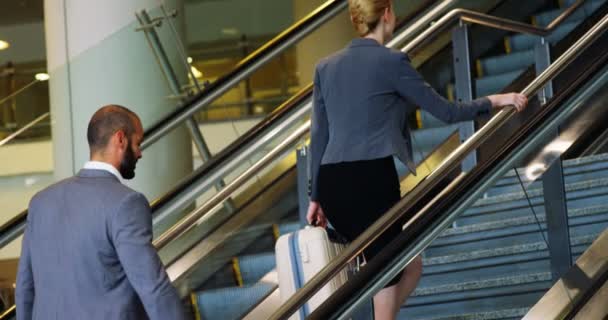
left=309, top=67, right=329, bottom=201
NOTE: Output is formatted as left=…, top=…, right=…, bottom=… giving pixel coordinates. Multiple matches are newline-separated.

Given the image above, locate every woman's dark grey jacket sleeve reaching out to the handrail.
left=389, top=53, right=492, bottom=123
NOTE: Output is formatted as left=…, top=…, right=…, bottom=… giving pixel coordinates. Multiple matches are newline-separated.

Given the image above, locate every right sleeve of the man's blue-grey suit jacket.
left=111, top=193, right=184, bottom=320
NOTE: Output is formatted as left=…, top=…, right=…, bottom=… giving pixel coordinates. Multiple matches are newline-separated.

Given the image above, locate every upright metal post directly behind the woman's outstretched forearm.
left=452, top=21, right=477, bottom=171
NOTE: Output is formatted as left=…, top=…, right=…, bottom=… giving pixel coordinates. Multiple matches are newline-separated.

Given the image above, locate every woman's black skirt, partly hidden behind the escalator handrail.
left=318, top=157, right=401, bottom=287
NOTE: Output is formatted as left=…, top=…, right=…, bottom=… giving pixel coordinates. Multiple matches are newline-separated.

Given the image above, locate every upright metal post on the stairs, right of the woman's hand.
left=534, top=38, right=572, bottom=281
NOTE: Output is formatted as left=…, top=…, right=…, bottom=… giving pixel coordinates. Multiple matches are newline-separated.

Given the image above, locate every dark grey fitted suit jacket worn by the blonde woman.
left=310, top=38, right=492, bottom=201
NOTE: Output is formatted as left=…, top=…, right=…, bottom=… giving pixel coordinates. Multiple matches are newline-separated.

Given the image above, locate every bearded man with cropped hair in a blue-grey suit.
left=16, top=105, right=184, bottom=320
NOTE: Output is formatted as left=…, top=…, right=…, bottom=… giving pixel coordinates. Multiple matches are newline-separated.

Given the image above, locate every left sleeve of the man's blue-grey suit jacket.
left=15, top=210, right=36, bottom=320
